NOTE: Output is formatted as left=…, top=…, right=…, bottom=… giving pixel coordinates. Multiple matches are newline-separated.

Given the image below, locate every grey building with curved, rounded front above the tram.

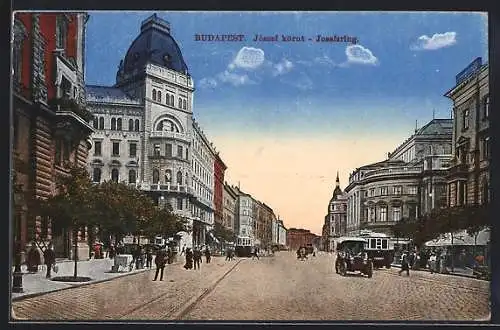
left=345, top=119, right=452, bottom=236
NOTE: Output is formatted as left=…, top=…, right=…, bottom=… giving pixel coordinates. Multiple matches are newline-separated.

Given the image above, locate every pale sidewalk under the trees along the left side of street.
left=11, top=258, right=154, bottom=300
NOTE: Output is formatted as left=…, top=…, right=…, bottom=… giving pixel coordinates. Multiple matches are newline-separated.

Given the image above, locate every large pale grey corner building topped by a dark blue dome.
left=87, top=14, right=216, bottom=245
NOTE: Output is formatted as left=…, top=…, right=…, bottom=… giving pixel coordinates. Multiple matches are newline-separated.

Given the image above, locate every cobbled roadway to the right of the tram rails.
left=184, top=252, right=489, bottom=320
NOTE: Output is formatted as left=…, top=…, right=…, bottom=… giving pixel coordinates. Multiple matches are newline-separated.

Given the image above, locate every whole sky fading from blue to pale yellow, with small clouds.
left=85, top=12, right=488, bottom=235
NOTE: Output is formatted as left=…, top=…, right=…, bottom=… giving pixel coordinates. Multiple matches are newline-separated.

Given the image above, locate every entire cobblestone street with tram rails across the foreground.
left=13, top=252, right=489, bottom=320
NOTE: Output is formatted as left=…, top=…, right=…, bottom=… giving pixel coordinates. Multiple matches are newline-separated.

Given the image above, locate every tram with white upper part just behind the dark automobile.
left=357, top=230, right=394, bottom=268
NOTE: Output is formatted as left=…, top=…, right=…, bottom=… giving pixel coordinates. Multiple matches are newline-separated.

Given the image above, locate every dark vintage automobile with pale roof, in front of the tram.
left=335, top=237, right=373, bottom=278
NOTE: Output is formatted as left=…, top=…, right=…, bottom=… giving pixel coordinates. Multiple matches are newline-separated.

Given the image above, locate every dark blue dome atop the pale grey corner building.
left=123, top=14, right=188, bottom=74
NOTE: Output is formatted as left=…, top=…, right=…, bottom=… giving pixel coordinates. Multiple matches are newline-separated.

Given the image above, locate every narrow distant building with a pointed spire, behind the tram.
left=323, top=172, right=347, bottom=251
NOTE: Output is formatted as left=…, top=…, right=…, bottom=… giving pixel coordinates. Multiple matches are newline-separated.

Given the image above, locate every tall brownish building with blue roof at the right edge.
left=445, top=58, right=491, bottom=207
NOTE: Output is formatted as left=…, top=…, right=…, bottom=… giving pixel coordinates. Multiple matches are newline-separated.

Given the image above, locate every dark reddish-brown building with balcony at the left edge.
left=11, top=12, right=92, bottom=258
